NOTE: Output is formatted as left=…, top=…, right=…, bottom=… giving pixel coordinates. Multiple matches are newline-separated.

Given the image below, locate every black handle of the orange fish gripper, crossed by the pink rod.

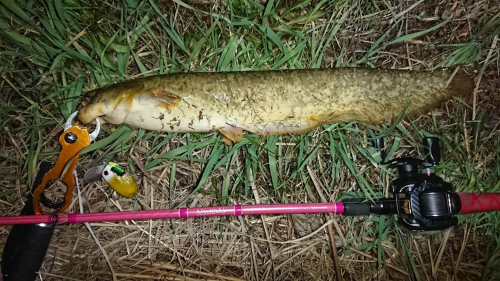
left=1, top=162, right=55, bottom=281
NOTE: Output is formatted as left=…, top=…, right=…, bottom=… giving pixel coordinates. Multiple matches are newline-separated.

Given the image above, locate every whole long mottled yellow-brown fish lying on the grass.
left=78, top=66, right=476, bottom=144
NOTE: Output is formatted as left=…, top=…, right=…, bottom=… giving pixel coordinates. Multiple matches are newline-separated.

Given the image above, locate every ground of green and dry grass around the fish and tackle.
left=0, top=0, right=500, bottom=280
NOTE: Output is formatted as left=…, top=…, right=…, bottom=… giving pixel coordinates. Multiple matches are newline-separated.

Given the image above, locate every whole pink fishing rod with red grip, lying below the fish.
left=0, top=189, right=500, bottom=226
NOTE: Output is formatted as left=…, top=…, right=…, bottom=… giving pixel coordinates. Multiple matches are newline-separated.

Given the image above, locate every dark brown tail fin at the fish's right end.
left=447, top=63, right=478, bottom=97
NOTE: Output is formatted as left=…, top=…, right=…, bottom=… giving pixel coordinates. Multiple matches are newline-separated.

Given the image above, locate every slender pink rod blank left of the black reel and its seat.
left=0, top=203, right=344, bottom=225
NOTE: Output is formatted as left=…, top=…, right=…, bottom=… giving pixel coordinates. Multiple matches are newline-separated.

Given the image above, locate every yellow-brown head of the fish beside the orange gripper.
left=78, top=80, right=144, bottom=124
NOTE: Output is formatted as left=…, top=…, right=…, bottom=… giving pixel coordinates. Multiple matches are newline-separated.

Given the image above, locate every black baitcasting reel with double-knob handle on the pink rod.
left=344, top=137, right=461, bottom=231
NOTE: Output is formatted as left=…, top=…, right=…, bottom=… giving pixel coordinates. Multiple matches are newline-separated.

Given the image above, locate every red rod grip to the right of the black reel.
left=457, top=192, right=500, bottom=214
